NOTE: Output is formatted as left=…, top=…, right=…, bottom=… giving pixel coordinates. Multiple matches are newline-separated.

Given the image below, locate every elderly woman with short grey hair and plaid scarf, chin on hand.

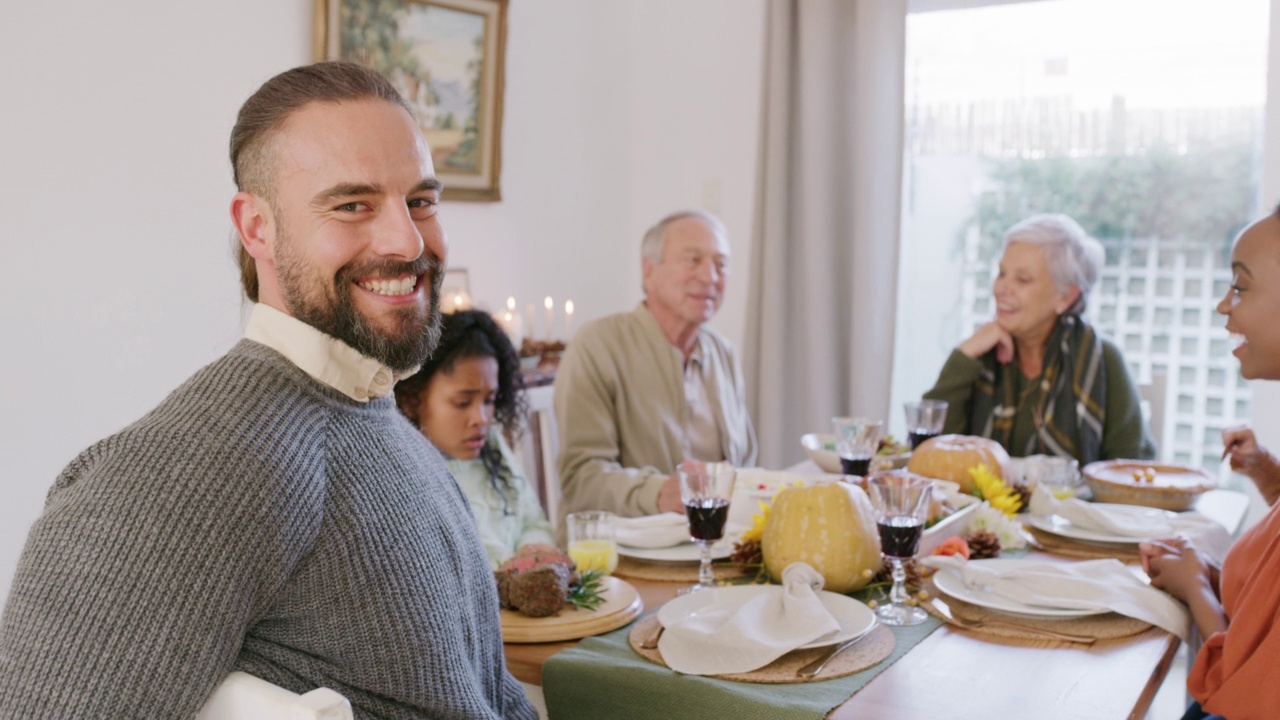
left=924, top=214, right=1156, bottom=465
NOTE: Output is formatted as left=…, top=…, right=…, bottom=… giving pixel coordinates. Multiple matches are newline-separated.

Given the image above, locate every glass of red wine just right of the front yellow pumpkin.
left=867, top=473, right=933, bottom=625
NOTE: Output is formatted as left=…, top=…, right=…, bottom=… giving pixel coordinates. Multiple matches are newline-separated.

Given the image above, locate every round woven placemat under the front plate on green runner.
left=627, top=612, right=895, bottom=685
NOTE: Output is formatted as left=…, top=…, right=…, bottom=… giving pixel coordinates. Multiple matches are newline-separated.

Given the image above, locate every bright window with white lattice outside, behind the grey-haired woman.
left=891, top=0, right=1270, bottom=468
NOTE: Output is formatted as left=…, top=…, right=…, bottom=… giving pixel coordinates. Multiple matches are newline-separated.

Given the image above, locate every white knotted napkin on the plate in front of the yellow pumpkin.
left=658, top=562, right=840, bottom=675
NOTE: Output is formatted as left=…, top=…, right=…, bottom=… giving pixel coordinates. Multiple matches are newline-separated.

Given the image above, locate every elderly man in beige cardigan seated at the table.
left=556, top=211, right=756, bottom=515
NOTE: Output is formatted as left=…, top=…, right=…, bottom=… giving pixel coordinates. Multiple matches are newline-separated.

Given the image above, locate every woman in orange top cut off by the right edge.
left=1140, top=208, right=1280, bottom=720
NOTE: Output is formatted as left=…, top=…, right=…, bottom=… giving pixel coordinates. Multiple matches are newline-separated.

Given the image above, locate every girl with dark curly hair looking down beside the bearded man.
left=396, top=310, right=556, bottom=568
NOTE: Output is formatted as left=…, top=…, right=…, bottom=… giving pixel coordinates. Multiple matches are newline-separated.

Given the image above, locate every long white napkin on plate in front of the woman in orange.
left=920, top=555, right=1190, bottom=641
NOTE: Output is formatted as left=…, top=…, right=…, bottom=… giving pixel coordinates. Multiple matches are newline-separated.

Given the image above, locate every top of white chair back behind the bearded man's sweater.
left=196, top=671, right=355, bottom=720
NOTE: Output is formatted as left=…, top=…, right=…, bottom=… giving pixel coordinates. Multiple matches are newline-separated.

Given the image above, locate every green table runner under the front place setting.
left=543, top=604, right=942, bottom=720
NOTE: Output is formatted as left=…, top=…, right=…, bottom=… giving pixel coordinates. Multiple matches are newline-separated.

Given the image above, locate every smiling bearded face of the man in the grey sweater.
left=259, top=100, right=447, bottom=370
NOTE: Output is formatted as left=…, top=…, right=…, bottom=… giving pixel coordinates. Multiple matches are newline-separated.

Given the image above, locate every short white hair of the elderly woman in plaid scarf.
left=1004, top=213, right=1106, bottom=314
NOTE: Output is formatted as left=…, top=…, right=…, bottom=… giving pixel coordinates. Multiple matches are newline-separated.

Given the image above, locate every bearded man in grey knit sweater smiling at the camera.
left=0, top=63, right=536, bottom=719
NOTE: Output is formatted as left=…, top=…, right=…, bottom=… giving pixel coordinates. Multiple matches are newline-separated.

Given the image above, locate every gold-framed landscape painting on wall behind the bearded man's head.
left=315, top=0, right=507, bottom=200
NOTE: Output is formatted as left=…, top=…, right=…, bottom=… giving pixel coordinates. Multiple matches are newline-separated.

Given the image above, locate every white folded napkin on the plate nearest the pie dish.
left=1029, top=488, right=1231, bottom=562
